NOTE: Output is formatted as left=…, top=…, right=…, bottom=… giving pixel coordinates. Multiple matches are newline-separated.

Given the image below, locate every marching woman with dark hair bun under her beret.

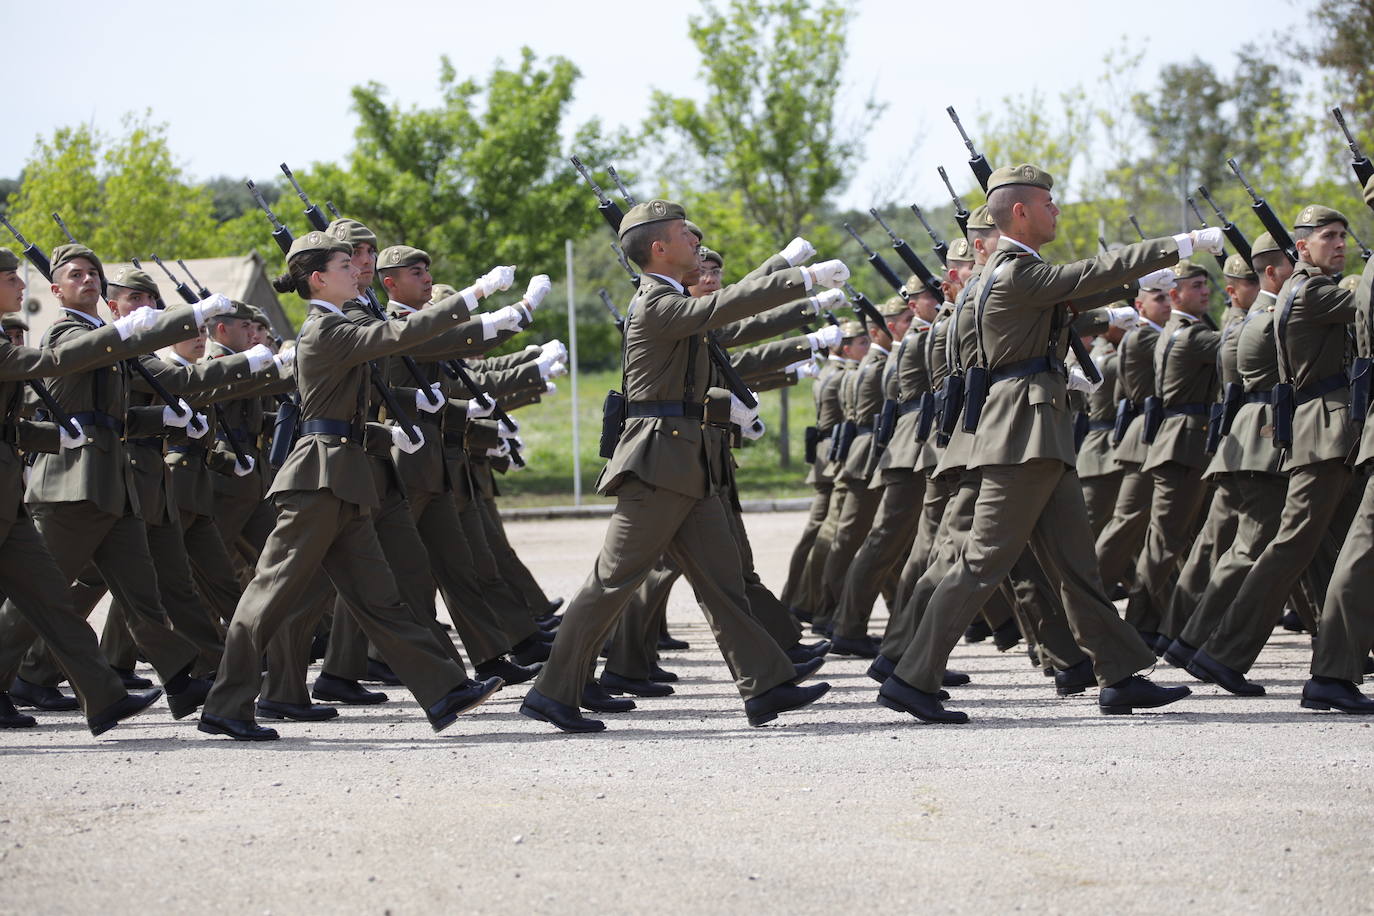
left=199, top=232, right=513, bottom=740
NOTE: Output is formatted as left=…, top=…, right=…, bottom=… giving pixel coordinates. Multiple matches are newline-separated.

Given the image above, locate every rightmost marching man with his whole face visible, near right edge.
left=1189, top=205, right=1356, bottom=696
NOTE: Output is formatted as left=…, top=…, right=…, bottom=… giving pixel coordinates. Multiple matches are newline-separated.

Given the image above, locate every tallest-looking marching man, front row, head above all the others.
left=879, top=165, right=1221, bottom=722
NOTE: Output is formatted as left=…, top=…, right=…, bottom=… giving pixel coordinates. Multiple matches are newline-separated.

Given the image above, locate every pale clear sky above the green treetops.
left=13, top=0, right=1311, bottom=206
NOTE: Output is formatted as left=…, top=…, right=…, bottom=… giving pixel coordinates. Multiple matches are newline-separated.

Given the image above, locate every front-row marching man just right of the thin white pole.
left=521, top=201, right=849, bottom=731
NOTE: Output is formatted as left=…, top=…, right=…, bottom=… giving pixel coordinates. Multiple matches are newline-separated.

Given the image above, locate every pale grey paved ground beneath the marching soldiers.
left=0, top=514, right=1374, bottom=915
